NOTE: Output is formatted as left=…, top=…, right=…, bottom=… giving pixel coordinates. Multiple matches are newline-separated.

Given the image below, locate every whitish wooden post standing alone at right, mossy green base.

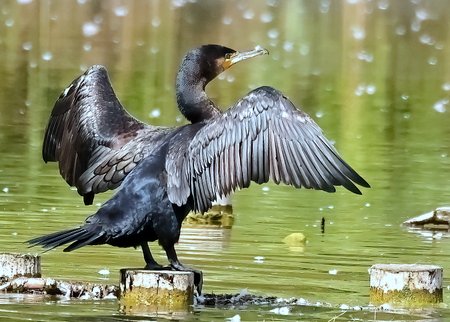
left=369, top=264, right=443, bottom=306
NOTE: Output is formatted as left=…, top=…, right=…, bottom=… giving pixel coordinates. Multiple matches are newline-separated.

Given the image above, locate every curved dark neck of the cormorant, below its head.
left=176, top=66, right=221, bottom=123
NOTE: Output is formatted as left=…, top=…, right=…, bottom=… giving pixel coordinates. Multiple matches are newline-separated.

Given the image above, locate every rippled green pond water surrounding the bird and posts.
left=0, top=0, right=450, bottom=321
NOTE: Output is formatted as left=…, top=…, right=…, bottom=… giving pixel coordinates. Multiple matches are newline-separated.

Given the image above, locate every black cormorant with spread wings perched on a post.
left=29, top=45, right=369, bottom=288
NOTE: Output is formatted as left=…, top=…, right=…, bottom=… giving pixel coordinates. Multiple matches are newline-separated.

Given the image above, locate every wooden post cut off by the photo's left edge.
left=0, top=253, right=41, bottom=279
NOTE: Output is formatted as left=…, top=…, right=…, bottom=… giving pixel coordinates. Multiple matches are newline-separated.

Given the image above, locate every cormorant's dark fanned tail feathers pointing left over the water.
left=27, top=227, right=105, bottom=252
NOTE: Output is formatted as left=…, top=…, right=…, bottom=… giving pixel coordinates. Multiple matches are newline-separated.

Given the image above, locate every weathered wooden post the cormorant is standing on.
left=120, top=268, right=194, bottom=314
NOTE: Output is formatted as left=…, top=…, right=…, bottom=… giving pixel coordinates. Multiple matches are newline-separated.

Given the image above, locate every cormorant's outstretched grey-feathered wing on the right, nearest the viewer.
left=166, top=87, right=370, bottom=212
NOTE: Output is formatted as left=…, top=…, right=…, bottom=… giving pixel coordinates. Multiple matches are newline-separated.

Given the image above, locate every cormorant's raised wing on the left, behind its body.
left=42, top=65, right=163, bottom=204
